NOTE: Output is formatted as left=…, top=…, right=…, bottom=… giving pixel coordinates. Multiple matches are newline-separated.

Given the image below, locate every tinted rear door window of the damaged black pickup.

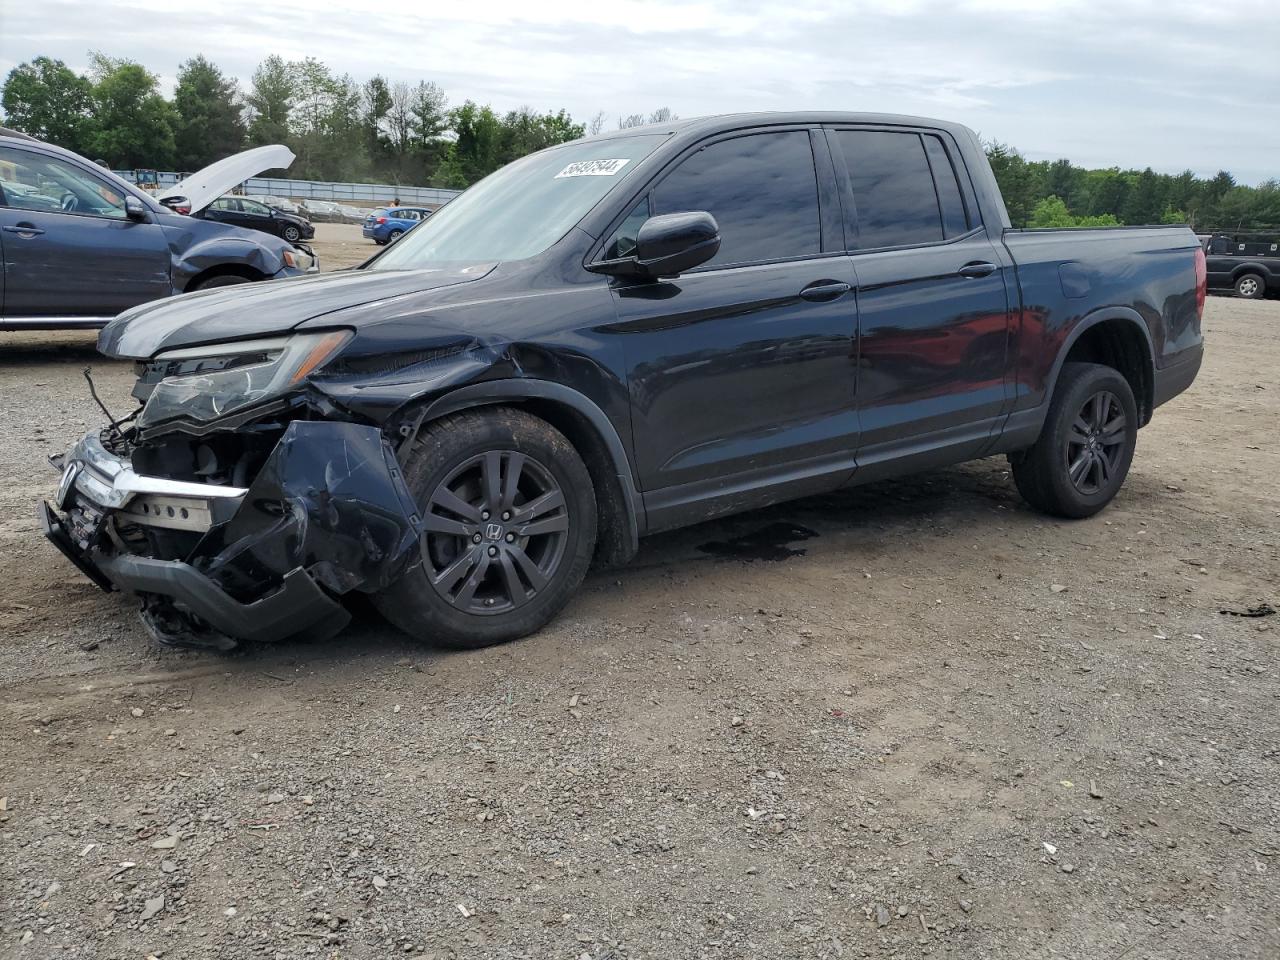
left=836, top=131, right=947, bottom=250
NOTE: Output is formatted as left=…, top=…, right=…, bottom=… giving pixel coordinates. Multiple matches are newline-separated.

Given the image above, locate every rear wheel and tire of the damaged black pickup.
left=1010, top=364, right=1138, bottom=518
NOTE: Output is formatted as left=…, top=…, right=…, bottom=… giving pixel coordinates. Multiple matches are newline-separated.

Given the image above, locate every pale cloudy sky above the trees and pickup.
left=0, top=0, right=1280, bottom=184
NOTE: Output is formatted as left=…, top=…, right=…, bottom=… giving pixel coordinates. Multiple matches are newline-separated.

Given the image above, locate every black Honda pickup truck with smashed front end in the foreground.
left=40, top=113, right=1206, bottom=646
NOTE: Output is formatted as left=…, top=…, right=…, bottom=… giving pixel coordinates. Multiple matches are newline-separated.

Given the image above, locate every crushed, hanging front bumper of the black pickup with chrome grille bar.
left=38, top=421, right=420, bottom=649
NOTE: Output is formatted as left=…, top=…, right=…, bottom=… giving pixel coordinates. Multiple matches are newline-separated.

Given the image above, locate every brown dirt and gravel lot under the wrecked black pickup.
left=0, top=253, right=1280, bottom=960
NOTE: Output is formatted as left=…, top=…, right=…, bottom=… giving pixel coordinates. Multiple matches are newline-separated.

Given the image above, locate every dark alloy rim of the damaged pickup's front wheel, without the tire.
left=424, top=451, right=570, bottom=614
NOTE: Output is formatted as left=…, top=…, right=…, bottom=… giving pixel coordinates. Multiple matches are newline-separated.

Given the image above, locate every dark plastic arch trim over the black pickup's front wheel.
left=393, top=379, right=644, bottom=566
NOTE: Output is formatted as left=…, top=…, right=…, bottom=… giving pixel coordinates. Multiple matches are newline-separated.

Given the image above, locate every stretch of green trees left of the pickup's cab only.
left=0, top=52, right=673, bottom=188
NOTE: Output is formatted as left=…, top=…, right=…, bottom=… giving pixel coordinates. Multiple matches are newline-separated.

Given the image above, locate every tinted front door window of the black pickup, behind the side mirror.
left=650, top=131, right=822, bottom=266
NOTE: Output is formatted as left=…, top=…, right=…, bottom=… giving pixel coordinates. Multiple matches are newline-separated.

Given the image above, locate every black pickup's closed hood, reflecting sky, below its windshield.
left=97, top=264, right=494, bottom=360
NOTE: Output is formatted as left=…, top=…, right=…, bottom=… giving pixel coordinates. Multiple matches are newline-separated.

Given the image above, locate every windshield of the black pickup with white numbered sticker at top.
left=369, top=134, right=666, bottom=270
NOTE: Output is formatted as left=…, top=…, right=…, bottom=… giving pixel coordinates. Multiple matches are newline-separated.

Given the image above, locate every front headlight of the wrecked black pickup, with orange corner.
left=138, top=330, right=352, bottom=428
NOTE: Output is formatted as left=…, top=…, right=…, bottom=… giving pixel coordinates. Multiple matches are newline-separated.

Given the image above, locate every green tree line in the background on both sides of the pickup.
left=0, top=52, right=1280, bottom=232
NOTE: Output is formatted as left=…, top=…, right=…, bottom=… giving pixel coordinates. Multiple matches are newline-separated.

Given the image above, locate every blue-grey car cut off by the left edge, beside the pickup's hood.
left=0, top=133, right=315, bottom=330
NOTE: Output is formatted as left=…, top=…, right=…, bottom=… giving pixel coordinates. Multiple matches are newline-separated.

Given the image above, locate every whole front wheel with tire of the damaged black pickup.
left=374, top=407, right=596, bottom=650
